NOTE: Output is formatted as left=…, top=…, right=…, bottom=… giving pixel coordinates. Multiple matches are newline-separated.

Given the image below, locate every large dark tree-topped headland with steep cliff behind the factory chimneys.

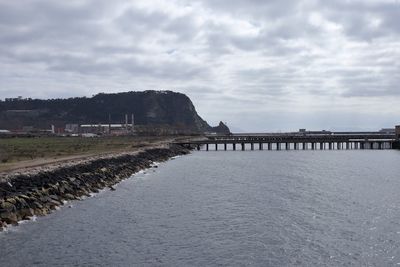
left=0, top=91, right=220, bottom=132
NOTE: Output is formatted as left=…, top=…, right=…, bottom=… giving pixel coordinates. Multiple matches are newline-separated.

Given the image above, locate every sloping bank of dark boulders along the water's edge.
left=0, top=145, right=190, bottom=231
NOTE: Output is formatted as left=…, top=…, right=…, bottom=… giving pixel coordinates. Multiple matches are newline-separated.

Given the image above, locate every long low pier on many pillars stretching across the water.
left=178, top=131, right=398, bottom=151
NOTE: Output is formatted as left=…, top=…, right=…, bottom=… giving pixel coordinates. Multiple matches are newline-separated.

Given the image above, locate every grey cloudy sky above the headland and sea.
left=0, top=0, right=400, bottom=132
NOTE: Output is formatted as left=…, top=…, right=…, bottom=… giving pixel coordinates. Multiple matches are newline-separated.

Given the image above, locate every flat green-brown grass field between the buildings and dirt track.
left=0, top=136, right=165, bottom=169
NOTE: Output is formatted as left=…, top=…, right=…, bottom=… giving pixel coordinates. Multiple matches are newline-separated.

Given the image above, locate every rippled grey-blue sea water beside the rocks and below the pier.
left=0, top=151, right=400, bottom=266
